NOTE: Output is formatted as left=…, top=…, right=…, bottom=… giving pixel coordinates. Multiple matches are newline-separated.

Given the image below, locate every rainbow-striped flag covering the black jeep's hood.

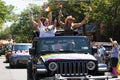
left=41, top=53, right=97, bottom=62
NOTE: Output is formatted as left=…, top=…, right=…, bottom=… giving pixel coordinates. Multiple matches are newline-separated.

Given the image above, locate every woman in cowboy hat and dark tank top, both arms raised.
left=58, top=10, right=89, bottom=35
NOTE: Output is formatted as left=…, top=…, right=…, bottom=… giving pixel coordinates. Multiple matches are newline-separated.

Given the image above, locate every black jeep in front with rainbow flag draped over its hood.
left=27, top=36, right=110, bottom=80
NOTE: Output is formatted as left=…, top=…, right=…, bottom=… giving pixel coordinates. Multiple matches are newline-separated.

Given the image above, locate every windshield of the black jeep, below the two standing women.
left=37, top=36, right=90, bottom=53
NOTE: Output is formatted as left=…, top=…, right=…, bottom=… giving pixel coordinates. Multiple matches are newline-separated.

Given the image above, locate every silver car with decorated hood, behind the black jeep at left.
left=9, top=43, right=32, bottom=68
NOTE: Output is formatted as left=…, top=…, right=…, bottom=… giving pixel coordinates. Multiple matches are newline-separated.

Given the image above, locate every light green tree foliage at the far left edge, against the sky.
left=0, top=0, right=16, bottom=38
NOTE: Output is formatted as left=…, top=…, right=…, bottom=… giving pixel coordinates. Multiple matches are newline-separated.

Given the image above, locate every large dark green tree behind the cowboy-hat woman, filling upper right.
left=49, top=0, right=120, bottom=41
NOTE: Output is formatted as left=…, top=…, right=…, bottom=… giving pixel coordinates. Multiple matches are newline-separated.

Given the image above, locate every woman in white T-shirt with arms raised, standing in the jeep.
left=30, top=10, right=57, bottom=37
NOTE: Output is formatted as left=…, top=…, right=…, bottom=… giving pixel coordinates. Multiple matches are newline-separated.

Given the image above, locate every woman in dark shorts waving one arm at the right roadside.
left=109, top=38, right=118, bottom=78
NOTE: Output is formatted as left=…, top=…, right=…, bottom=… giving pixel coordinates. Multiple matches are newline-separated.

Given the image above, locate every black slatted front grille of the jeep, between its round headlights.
left=57, top=61, right=88, bottom=76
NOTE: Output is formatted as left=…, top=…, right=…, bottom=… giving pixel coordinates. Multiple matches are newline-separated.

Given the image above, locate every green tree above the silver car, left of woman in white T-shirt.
left=10, top=5, right=40, bottom=42
